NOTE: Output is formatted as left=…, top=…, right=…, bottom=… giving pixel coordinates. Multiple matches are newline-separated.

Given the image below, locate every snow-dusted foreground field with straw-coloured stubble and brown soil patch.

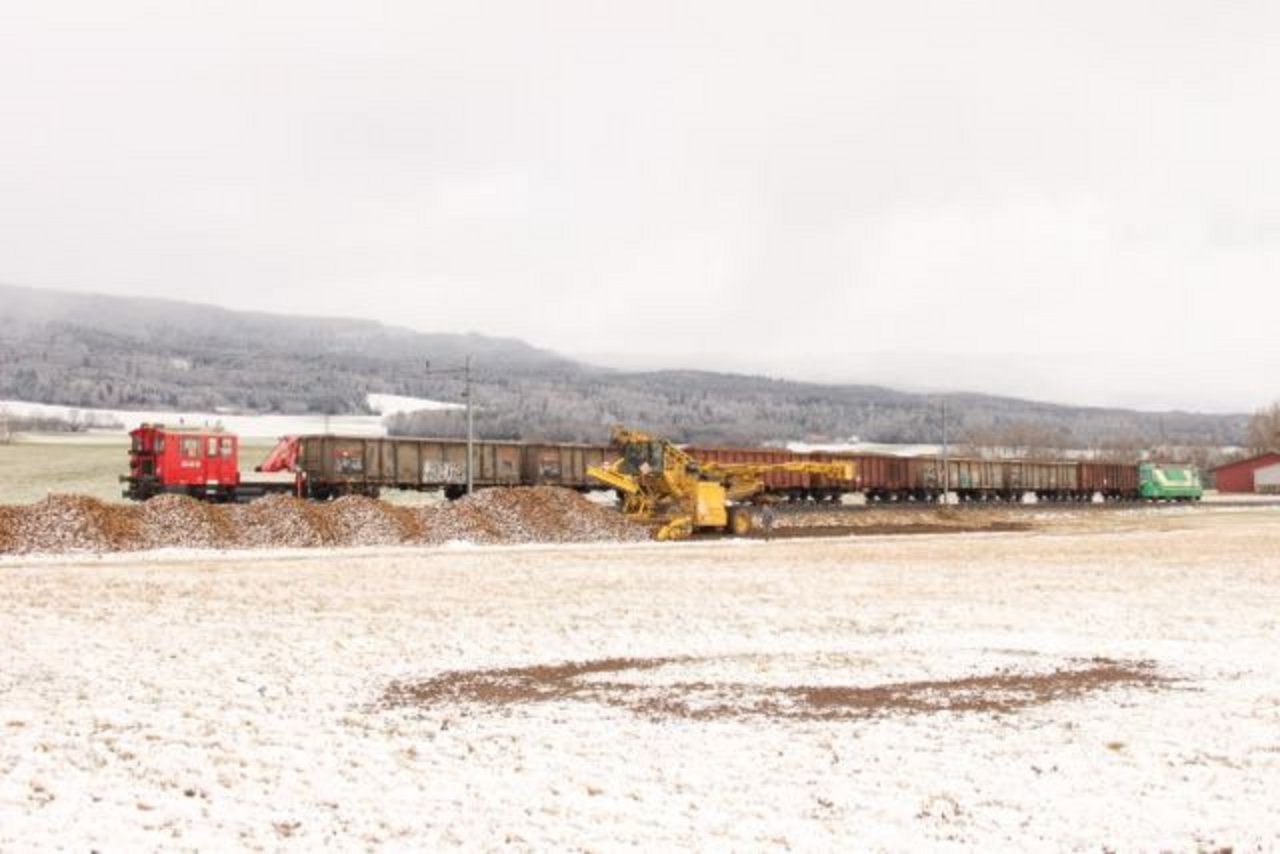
left=0, top=510, right=1280, bottom=850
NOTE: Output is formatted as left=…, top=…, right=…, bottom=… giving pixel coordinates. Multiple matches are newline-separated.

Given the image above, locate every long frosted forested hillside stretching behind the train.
left=0, top=286, right=1247, bottom=447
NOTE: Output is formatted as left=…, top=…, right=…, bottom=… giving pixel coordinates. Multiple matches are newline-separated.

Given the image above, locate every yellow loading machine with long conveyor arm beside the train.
left=586, top=426, right=854, bottom=540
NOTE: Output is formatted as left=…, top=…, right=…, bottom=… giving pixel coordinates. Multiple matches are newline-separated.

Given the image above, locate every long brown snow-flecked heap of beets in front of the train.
left=0, top=487, right=649, bottom=553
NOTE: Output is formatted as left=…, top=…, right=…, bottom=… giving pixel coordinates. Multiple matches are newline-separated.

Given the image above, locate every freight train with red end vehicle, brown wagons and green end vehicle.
left=120, top=424, right=1203, bottom=503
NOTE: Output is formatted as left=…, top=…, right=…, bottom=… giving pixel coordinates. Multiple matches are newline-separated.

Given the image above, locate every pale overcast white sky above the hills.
left=0, top=0, right=1280, bottom=410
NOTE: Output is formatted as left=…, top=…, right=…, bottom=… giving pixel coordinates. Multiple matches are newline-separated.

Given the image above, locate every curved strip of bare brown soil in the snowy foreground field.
left=381, top=657, right=1169, bottom=721
